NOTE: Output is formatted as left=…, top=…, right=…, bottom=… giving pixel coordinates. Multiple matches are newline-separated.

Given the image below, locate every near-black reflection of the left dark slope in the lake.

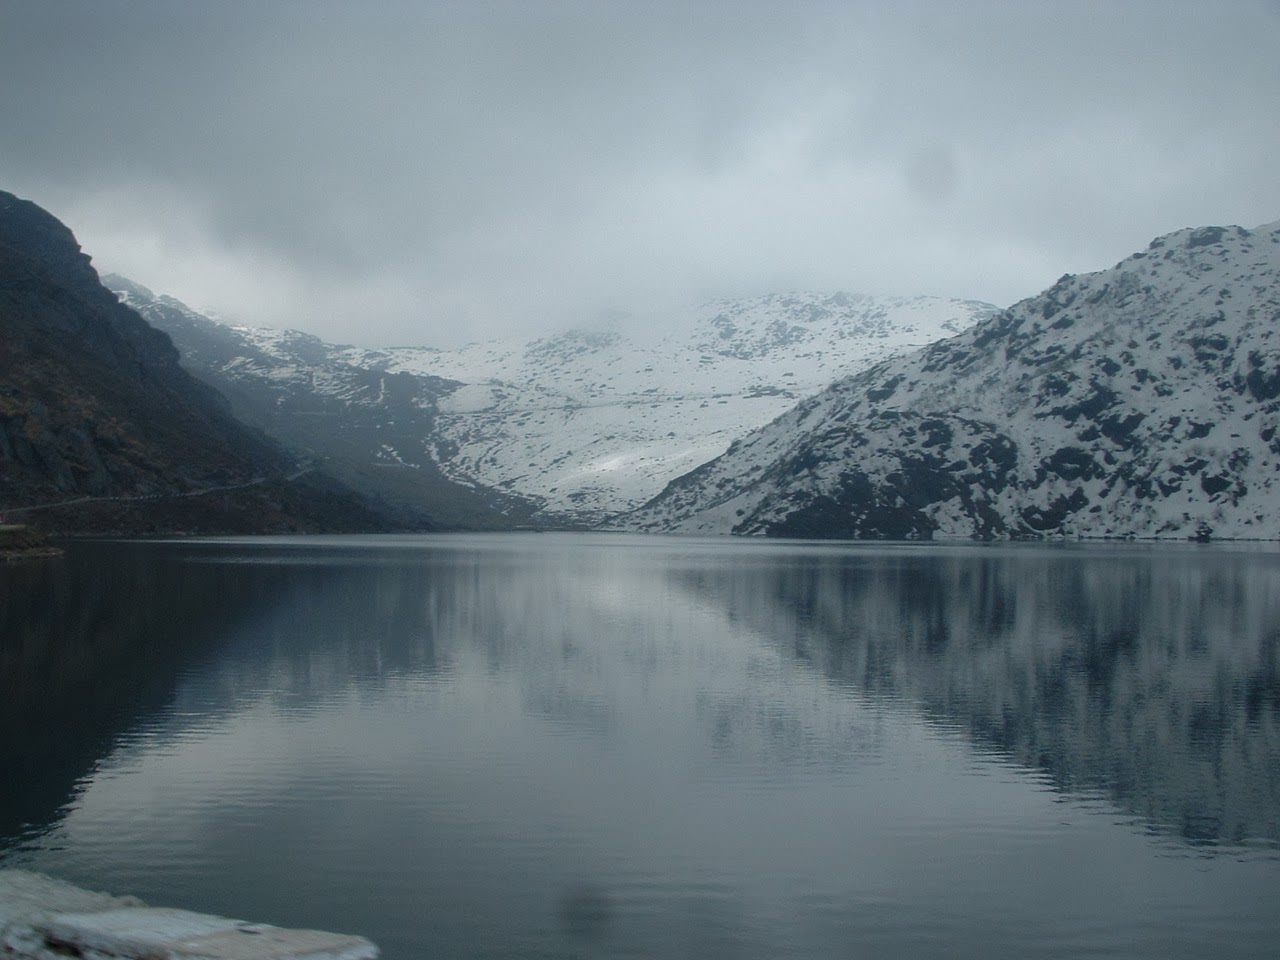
left=0, top=544, right=289, bottom=849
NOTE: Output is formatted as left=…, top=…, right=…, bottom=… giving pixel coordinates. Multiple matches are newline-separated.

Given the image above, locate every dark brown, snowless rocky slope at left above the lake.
left=0, top=192, right=384, bottom=531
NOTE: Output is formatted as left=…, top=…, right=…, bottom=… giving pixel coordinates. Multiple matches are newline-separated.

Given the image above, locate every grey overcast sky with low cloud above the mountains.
left=0, top=0, right=1280, bottom=346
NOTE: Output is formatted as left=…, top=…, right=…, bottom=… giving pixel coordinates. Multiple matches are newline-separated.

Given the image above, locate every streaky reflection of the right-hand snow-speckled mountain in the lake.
left=673, top=547, right=1280, bottom=844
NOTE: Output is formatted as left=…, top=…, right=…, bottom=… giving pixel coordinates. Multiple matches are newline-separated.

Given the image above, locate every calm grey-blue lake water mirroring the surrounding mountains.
left=0, top=534, right=1280, bottom=960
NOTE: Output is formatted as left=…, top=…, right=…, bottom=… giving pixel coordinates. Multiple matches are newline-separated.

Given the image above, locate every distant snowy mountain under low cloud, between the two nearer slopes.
left=109, top=278, right=996, bottom=524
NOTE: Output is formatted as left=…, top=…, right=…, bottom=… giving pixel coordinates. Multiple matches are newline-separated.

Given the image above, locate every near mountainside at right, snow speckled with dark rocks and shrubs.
left=620, top=223, right=1280, bottom=539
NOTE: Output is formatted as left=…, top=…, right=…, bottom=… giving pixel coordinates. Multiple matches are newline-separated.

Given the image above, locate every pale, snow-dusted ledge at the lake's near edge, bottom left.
left=0, top=870, right=378, bottom=960
